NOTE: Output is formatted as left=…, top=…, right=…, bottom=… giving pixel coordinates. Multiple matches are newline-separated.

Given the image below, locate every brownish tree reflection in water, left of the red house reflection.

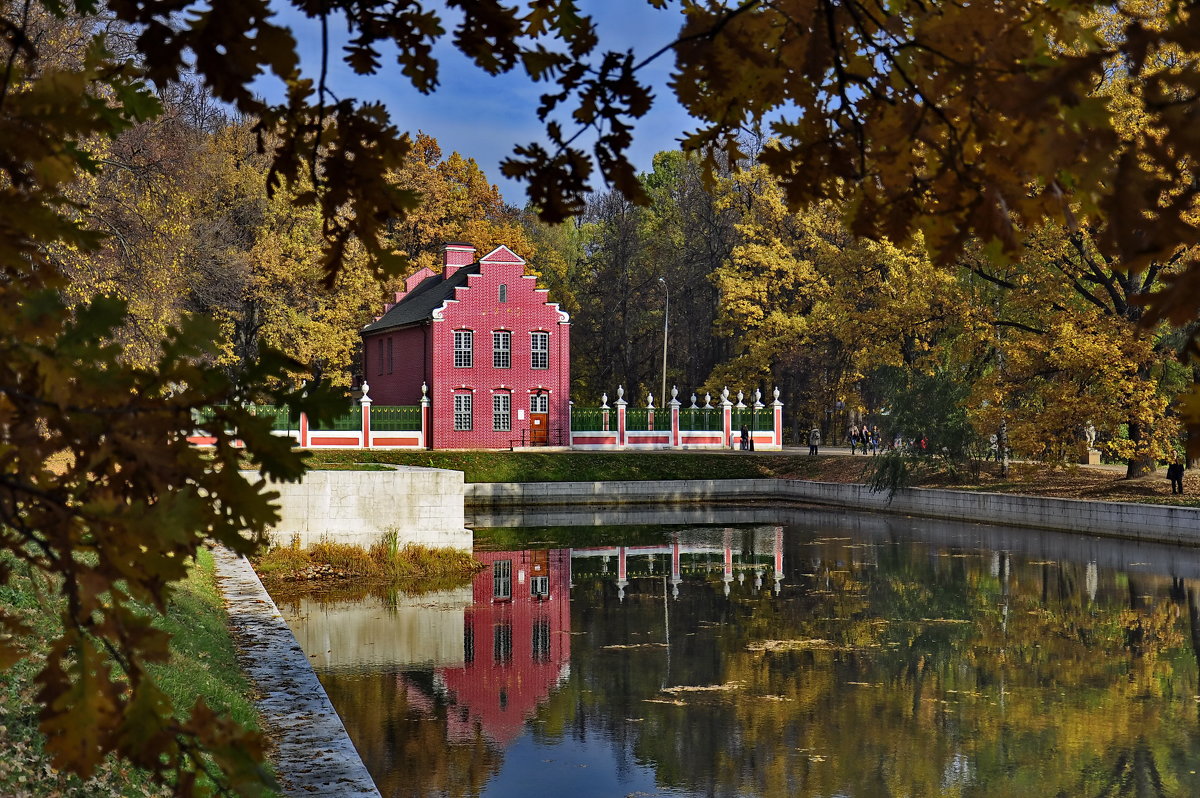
left=320, top=672, right=503, bottom=798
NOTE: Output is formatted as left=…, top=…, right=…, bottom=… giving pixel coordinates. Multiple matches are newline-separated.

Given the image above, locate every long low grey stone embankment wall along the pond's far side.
left=463, top=479, right=1200, bottom=546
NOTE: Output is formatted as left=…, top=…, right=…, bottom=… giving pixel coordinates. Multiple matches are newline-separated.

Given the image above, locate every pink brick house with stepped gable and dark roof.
left=361, top=244, right=571, bottom=449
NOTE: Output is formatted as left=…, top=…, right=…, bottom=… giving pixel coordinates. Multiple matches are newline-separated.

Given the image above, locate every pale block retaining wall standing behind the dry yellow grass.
left=258, top=466, right=472, bottom=550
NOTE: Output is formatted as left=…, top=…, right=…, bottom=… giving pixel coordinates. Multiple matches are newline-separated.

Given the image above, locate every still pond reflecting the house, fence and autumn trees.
left=280, top=508, right=1200, bottom=798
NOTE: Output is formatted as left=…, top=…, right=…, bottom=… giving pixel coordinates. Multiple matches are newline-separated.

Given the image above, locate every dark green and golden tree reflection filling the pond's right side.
left=539, top=540, right=1200, bottom=797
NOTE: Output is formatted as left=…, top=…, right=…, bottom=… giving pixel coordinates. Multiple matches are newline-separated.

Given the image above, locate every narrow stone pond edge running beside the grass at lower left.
left=212, top=548, right=379, bottom=798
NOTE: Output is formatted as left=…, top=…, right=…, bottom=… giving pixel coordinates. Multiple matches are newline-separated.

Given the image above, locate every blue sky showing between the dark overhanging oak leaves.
left=258, top=0, right=692, bottom=205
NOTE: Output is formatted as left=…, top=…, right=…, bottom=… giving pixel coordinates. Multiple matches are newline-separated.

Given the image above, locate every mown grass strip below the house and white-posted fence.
left=300, top=450, right=821, bottom=482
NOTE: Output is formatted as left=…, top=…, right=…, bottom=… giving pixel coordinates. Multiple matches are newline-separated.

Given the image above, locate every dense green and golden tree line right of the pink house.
left=542, top=147, right=1189, bottom=474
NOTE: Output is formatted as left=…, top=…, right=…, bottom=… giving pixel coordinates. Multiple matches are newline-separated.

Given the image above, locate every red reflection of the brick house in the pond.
left=437, top=548, right=571, bottom=745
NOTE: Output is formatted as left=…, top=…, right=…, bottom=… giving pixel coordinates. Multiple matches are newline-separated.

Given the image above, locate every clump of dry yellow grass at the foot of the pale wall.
left=253, top=529, right=484, bottom=582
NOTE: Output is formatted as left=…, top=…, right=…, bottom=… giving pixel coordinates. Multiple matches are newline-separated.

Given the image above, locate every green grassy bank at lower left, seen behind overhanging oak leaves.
left=0, top=551, right=274, bottom=798
